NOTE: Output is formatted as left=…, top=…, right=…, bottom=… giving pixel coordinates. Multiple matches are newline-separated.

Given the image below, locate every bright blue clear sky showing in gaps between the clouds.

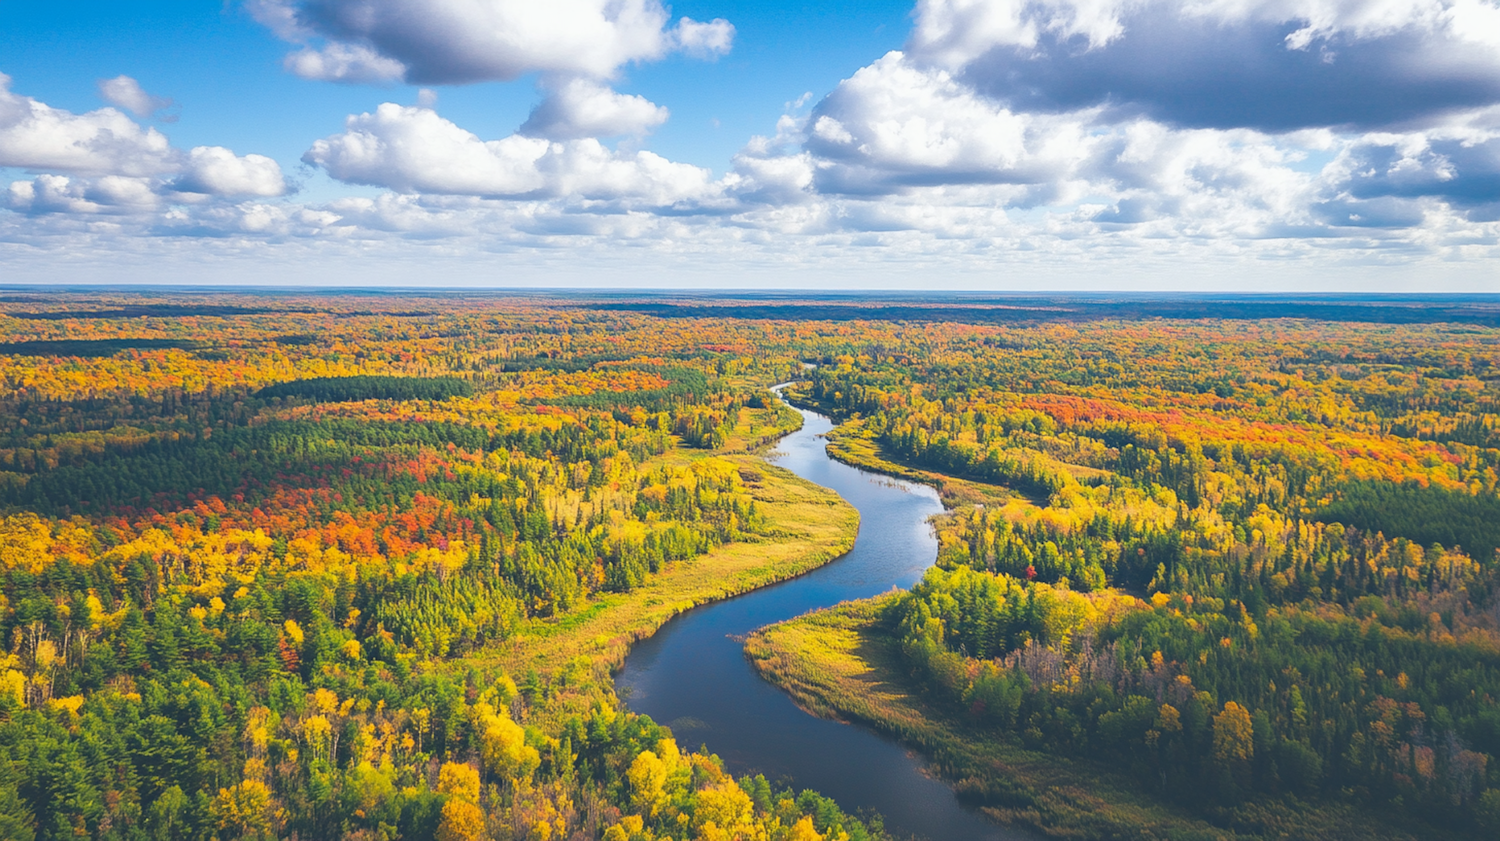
left=0, top=0, right=912, bottom=171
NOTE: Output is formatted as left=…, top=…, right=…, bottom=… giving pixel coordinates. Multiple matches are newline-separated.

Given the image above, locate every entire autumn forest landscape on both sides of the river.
left=0, top=292, right=1500, bottom=841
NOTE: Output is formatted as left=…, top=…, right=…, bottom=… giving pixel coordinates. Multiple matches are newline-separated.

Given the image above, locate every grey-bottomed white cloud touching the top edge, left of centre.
left=251, top=0, right=734, bottom=84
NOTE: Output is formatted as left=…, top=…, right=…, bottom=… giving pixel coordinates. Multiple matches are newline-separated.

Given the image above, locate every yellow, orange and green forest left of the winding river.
left=0, top=300, right=884, bottom=841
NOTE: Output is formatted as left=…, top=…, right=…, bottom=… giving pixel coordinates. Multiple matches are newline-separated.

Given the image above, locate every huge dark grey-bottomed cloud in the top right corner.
left=908, top=0, right=1500, bottom=132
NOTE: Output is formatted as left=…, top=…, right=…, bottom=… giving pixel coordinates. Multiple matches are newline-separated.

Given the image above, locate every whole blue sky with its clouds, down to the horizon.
left=0, top=0, right=1500, bottom=292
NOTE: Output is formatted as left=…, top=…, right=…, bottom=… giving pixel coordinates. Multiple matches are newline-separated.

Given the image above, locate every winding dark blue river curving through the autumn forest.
left=617, top=392, right=1029, bottom=841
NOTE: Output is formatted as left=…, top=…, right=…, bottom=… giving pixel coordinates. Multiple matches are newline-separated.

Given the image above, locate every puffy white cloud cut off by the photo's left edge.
left=0, top=73, right=173, bottom=175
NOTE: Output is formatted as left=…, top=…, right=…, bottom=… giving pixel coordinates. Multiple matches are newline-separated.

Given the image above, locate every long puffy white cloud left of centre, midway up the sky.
left=303, top=102, right=713, bottom=205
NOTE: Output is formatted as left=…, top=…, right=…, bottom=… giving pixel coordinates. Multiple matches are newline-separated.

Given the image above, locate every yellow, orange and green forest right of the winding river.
left=786, top=314, right=1500, bottom=832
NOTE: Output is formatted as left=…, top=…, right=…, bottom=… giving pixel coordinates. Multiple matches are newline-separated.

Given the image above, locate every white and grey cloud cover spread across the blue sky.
left=0, top=0, right=1500, bottom=284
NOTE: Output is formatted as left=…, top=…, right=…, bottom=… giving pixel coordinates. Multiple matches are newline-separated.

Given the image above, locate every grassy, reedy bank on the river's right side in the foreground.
left=746, top=595, right=1458, bottom=841
